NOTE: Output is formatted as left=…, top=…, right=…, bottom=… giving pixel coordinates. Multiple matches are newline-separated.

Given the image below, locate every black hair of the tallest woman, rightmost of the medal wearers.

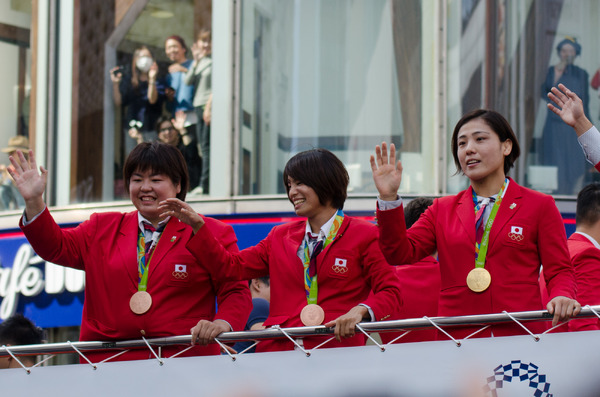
left=452, top=109, right=521, bottom=175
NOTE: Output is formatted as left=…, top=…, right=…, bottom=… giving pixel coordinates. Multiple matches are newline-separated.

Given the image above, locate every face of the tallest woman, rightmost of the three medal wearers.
left=457, top=118, right=512, bottom=184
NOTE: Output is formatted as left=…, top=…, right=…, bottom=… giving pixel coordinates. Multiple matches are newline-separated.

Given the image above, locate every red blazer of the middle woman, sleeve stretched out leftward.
left=187, top=216, right=401, bottom=351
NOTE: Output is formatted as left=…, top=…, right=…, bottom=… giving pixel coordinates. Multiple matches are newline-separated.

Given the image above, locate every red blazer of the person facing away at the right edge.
left=568, top=233, right=600, bottom=331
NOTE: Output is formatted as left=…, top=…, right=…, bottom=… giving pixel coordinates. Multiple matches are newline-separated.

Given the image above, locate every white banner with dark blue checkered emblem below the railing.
left=0, top=331, right=600, bottom=397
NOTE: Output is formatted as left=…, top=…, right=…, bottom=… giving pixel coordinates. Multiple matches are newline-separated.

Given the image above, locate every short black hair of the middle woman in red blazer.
left=283, top=148, right=350, bottom=209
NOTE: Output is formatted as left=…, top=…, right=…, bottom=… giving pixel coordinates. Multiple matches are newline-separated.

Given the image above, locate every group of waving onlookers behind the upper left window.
left=110, top=29, right=212, bottom=195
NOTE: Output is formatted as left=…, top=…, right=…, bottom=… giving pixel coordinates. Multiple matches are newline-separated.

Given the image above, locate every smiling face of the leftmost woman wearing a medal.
left=129, top=169, right=181, bottom=225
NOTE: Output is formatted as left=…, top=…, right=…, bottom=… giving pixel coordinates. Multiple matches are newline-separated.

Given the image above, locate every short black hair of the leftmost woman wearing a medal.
left=123, top=141, right=190, bottom=201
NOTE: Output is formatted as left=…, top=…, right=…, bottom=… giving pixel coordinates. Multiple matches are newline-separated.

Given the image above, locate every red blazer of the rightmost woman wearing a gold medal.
left=377, top=179, right=576, bottom=337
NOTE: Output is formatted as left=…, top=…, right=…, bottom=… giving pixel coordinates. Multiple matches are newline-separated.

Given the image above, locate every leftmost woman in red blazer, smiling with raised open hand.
left=11, top=142, right=252, bottom=362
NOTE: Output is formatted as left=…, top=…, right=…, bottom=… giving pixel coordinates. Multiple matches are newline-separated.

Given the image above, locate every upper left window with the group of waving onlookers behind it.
left=104, top=0, right=211, bottom=199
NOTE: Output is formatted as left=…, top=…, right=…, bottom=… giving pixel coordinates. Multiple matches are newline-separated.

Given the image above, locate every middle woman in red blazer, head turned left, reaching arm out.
left=162, top=149, right=401, bottom=351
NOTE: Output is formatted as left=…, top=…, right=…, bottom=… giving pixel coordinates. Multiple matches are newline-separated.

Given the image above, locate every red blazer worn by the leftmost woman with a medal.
left=20, top=209, right=252, bottom=360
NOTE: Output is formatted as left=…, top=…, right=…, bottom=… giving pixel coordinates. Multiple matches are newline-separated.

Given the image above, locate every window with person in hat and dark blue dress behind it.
left=447, top=0, right=600, bottom=195
